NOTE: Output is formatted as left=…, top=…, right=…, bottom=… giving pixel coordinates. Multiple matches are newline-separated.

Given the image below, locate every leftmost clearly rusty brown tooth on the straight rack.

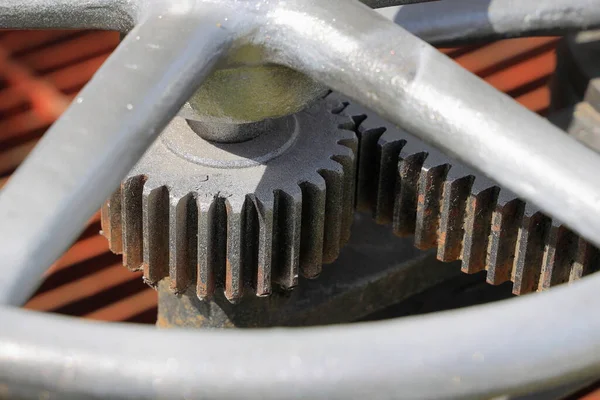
left=415, top=162, right=450, bottom=250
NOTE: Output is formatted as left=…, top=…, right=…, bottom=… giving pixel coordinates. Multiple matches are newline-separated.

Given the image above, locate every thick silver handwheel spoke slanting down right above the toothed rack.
left=265, top=1, right=600, bottom=252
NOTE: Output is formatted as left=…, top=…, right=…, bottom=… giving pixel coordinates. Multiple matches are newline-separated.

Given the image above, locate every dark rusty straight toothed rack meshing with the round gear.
left=344, top=100, right=600, bottom=295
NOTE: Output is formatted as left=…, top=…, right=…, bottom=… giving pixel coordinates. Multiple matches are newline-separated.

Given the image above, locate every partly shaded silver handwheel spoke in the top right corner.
left=392, top=0, right=600, bottom=46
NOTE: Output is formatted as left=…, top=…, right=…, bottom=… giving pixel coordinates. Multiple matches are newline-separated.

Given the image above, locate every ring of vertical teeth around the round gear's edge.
left=102, top=95, right=358, bottom=302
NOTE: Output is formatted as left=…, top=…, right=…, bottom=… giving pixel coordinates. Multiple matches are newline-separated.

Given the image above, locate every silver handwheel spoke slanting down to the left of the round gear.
left=0, top=9, right=232, bottom=304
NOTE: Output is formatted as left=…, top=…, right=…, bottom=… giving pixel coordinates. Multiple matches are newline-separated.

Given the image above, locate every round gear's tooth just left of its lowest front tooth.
left=196, top=196, right=227, bottom=300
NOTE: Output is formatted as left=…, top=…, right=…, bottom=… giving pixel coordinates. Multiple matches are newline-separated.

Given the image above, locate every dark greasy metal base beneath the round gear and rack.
left=157, top=214, right=460, bottom=328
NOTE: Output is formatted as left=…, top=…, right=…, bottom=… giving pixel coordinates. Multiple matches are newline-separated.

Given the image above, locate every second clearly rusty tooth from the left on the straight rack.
left=437, top=173, right=473, bottom=262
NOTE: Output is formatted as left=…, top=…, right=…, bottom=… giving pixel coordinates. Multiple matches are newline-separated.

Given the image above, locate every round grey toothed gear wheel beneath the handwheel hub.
left=102, top=96, right=358, bottom=302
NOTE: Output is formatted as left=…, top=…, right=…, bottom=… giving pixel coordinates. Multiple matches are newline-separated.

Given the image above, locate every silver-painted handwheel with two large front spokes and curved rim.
left=0, top=0, right=600, bottom=399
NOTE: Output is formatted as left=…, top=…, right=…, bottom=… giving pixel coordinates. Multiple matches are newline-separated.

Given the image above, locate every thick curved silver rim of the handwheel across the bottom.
left=0, top=275, right=600, bottom=399
